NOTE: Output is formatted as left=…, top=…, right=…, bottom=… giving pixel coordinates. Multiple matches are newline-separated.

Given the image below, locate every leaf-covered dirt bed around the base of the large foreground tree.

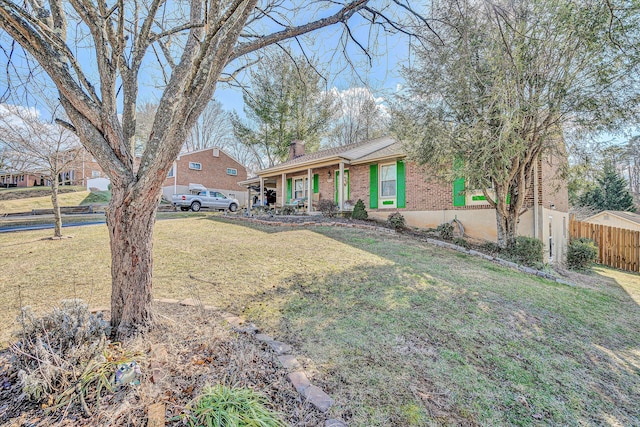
left=0, top=304, right=326, bottom=426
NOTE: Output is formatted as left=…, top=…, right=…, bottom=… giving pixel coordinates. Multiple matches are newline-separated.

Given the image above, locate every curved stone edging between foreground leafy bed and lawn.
left=223, top=313, right=347, bottom=427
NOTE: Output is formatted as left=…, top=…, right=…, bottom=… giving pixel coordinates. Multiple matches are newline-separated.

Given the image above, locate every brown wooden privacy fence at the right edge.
left=569, top=217, right=640, bottom=272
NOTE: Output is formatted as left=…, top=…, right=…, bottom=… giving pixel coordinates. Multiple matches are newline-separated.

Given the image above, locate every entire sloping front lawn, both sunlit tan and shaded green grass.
left=0, top=219, right=640, bottom=426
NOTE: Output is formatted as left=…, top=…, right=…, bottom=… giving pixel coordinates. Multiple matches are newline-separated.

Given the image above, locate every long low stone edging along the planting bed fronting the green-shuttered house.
left=221, top=216, right=576, bottom=287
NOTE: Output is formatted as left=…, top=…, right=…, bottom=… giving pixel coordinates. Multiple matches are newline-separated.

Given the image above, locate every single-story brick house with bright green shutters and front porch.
left=241, top=137, right=569, bottom=262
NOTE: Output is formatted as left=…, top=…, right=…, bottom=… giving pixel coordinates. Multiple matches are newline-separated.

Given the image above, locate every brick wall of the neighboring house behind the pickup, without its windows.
left=163, top=148, right=248, bottom=192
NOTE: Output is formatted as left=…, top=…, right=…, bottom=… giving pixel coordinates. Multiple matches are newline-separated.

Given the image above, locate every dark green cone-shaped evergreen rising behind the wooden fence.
left=578, top=162, right=636, bottom=212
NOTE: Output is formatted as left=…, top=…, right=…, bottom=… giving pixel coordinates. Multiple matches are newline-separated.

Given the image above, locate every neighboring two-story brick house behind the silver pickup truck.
left=162, top=148, right=247, bottom=206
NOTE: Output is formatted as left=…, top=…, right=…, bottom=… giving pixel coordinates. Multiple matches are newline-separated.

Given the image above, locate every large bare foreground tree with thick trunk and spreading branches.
left=0, top=0, right=430, bottom=336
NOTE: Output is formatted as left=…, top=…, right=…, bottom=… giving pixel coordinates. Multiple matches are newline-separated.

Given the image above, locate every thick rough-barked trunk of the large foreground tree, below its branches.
left=106, top=182, right=160, bottom=338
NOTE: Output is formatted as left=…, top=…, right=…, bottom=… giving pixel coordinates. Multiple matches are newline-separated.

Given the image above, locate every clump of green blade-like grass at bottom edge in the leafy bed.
left=184, top=384, right=286, bottom=427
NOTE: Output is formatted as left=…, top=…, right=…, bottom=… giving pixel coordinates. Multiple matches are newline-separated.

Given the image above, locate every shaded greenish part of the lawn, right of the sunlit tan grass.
left=234, top=227, right=640, bottom=426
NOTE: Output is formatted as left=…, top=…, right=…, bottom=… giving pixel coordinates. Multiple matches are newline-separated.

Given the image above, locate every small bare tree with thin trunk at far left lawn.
left=0, top=104, right=81, bottom=237
